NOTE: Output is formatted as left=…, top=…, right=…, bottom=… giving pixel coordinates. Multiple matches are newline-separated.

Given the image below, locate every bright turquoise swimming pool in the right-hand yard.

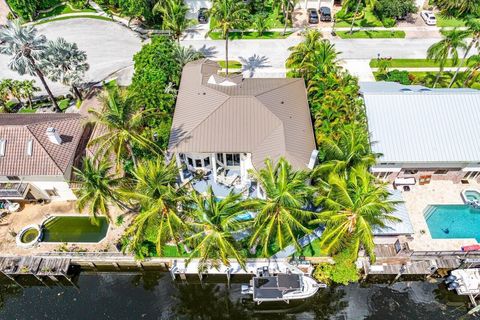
left=425, top=205, right=480, bottom=242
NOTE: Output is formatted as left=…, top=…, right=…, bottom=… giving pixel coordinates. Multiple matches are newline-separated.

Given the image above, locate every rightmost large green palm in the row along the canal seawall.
left=310, top=166, right=399, bottom=261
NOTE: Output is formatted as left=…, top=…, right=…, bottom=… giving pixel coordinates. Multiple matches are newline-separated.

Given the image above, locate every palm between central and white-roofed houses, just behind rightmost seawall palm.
left=315, top=124, right=376, bottom=175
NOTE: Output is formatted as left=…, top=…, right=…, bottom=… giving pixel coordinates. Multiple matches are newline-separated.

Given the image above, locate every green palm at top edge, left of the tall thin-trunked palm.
left=153, top=0, right=192, bottom=43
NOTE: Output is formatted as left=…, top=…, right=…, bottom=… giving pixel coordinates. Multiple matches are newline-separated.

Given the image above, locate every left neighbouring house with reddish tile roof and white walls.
left=0, top=113, right=89, bottom=201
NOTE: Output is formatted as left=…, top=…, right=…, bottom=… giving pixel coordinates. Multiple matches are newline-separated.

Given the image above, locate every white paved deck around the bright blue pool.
left=402, top=181, right=480, bottom=251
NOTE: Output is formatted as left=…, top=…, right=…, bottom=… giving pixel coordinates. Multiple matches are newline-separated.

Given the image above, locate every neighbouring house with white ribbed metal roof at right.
left=361, top=82, right=480, bottom=184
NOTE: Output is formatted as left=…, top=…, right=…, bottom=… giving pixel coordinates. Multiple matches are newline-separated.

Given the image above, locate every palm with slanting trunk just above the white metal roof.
left=427, top=28, right=469, bottom=88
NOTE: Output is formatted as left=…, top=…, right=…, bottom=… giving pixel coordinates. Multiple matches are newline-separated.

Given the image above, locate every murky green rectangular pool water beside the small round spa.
left=42, top=216, right=108, bottom=243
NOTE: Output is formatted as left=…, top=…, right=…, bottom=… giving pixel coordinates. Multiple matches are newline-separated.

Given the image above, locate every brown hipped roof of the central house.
left=169, top=60, right=316, bottom=168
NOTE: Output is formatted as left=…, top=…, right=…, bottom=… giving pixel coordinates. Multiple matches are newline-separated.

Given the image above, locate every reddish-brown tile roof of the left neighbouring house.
left=0, top=113, right=85, bottom=176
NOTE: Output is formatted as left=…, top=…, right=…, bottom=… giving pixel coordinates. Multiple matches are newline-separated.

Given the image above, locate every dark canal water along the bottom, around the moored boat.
left=0, top=272, right=474, bottom=320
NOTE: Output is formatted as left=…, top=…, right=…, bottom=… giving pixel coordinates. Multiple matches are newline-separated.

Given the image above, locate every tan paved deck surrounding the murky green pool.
left=0, top=202, right=131, bottom=256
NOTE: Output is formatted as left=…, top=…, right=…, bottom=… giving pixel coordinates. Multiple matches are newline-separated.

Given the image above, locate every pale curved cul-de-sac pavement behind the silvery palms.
left=0, top=18, right=142, bottom=95
